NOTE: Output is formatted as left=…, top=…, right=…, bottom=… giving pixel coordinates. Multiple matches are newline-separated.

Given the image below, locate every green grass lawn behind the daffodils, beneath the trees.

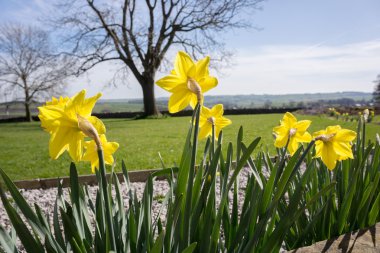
left=0, top=114, right=380, bottom=180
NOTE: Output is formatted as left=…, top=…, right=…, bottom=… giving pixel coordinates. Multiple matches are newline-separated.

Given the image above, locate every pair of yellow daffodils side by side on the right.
left=273, top=112, right=356, bottom=170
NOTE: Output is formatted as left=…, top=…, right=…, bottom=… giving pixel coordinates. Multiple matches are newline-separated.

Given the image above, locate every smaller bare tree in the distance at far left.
left=0, top=24, right=73, bottom=121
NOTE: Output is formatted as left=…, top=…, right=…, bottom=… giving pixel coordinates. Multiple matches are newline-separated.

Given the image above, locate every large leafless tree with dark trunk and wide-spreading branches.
left=49, top=0, right=263, bottom=115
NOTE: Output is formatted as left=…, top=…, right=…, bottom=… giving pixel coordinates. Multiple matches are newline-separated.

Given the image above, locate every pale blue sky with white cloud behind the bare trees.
left=0, top=0, right=380, bottom=98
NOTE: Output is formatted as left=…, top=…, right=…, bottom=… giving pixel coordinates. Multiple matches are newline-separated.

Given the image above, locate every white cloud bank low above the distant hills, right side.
left=211, top=40, right=380, bottom=94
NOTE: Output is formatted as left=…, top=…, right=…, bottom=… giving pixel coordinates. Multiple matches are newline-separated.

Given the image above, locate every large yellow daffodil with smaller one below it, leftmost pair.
left=38, top=90, right=119, bottom=172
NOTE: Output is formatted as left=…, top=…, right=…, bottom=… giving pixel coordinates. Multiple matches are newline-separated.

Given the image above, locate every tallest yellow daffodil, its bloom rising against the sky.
left=156, top=51, right=218, bottom=113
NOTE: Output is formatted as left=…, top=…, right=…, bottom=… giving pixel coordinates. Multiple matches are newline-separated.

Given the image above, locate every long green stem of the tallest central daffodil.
left=181, top=103, right=200, bottom=250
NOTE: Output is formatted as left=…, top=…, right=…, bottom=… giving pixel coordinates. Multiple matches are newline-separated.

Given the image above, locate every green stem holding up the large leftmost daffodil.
left=98, top=149, right=116, bottom=251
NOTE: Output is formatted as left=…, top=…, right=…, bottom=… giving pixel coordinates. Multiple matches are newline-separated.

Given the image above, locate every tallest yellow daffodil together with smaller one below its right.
left=156, top=51, right=231, bottom=139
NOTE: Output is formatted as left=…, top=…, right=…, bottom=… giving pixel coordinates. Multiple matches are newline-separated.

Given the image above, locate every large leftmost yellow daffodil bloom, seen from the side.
left=38, top=90, right=106, bottom=161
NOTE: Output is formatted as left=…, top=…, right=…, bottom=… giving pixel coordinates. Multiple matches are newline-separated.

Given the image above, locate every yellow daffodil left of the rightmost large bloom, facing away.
left=273, top=112, right=311, bottom=155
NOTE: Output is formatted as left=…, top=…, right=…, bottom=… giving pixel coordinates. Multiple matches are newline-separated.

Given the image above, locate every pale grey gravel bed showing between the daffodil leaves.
left=0, top=168, right=284, bottom=251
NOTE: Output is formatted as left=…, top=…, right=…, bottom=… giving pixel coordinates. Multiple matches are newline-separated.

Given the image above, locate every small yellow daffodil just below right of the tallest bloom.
left=199, top=104, right=232, bottom=139
